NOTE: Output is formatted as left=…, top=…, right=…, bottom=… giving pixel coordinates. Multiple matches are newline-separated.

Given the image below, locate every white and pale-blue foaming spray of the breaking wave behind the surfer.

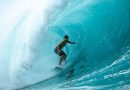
left=0, top=0, right=68, bottom=90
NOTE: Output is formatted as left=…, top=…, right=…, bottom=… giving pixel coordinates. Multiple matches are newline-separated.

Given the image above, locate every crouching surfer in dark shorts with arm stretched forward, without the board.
left=54, top=35, right=76, bottom=65
